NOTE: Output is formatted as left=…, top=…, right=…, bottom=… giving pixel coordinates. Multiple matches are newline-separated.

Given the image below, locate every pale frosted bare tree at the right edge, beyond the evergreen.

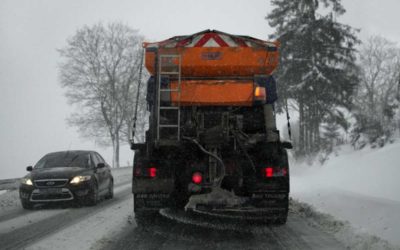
left=355, top=36, right=400, bottom=147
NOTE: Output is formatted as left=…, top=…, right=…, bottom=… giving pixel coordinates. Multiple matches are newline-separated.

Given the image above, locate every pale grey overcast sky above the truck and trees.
left=0, top=0, right=400, bottom=179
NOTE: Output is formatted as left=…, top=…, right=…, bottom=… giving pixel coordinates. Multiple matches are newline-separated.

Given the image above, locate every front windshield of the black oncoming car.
left=35, top=152, right=89, bottom=168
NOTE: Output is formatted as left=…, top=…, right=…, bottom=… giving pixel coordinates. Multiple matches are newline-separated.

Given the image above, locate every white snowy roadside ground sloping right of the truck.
left=291, top=142, right=400, bottom=247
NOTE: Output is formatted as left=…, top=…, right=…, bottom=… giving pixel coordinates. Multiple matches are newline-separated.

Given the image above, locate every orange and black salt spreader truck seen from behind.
left=131, top=30, right=291, bottom=224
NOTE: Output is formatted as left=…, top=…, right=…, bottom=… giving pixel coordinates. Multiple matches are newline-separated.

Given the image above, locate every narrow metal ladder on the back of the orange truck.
left=157, top=55, right=181, bottom=145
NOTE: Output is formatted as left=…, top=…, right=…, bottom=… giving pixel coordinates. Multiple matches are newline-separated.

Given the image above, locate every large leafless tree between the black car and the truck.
left=59, top=23, right=143, bottom=167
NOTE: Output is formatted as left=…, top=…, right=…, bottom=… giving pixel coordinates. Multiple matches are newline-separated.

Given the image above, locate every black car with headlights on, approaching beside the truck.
left=19, top=151, right=114, bottom=209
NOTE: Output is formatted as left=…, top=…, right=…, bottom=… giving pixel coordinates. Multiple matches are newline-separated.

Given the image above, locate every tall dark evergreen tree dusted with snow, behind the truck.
left=267, top=0, right=358, bottom=155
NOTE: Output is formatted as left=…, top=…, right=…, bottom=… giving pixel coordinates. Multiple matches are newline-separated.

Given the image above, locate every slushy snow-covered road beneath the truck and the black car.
left=0, top=162, right=396, bottom=250
